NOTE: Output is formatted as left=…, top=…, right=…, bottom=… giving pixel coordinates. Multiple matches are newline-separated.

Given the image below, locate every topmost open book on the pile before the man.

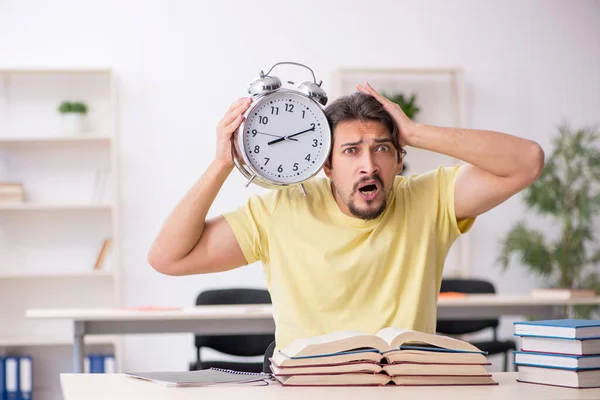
left=281, top=327, right=485, bottom=359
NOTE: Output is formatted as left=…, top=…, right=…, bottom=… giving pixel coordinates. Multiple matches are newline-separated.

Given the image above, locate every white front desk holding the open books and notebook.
left=60, top=372, right=600, bottom=400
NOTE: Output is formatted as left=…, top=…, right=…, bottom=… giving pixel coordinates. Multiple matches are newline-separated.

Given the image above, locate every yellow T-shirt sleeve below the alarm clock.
left=223, top=190, right=278, bottom=264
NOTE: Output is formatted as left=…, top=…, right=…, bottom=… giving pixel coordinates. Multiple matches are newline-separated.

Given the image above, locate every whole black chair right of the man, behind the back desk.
left=436, top=279, right=516, bottom=372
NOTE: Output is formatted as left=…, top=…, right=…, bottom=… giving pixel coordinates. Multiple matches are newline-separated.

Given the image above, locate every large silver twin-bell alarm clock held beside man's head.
left=232, top=62, right=331, bottom=194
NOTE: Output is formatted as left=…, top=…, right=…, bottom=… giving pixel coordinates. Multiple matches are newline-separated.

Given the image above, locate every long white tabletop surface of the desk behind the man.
left=25, top=295, right=600, bottom=321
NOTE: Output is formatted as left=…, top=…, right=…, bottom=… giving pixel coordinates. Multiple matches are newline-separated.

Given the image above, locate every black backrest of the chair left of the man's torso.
left=194, top=288, right=275, bottom=357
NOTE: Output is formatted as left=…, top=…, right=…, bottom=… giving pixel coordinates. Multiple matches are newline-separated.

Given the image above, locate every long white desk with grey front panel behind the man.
left=25, top=295, right=600, bottom=372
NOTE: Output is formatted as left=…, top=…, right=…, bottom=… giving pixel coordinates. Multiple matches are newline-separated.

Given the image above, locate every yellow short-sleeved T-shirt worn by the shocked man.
left=224, top=166, right=474, bottom=349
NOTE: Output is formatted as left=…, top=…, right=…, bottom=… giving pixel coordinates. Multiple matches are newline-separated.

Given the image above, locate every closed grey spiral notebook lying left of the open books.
left=125, top=368, right=273, bottom=387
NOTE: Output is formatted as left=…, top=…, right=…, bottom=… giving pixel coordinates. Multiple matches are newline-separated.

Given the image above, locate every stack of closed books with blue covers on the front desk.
left=514, top=319, right=600, bottom=388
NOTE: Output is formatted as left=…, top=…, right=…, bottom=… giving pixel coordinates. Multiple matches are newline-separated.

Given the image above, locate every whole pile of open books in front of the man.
left=271, top=327, right=498, bottom=386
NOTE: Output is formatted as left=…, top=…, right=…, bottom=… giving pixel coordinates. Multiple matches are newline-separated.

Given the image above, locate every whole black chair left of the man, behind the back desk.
left=190, top=288, right=275, bottom=372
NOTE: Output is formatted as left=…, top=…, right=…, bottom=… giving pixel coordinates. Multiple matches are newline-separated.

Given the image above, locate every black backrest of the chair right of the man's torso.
left=436, top=279, right=499, bottom=335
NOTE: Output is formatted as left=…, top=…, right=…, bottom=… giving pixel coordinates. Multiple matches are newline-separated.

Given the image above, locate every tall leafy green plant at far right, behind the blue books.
left=498, top=123, right=600, bottom=318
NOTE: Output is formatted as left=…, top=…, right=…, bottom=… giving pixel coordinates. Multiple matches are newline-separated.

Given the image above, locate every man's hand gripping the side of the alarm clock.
left=215, top=97, right=252, bottom=168
